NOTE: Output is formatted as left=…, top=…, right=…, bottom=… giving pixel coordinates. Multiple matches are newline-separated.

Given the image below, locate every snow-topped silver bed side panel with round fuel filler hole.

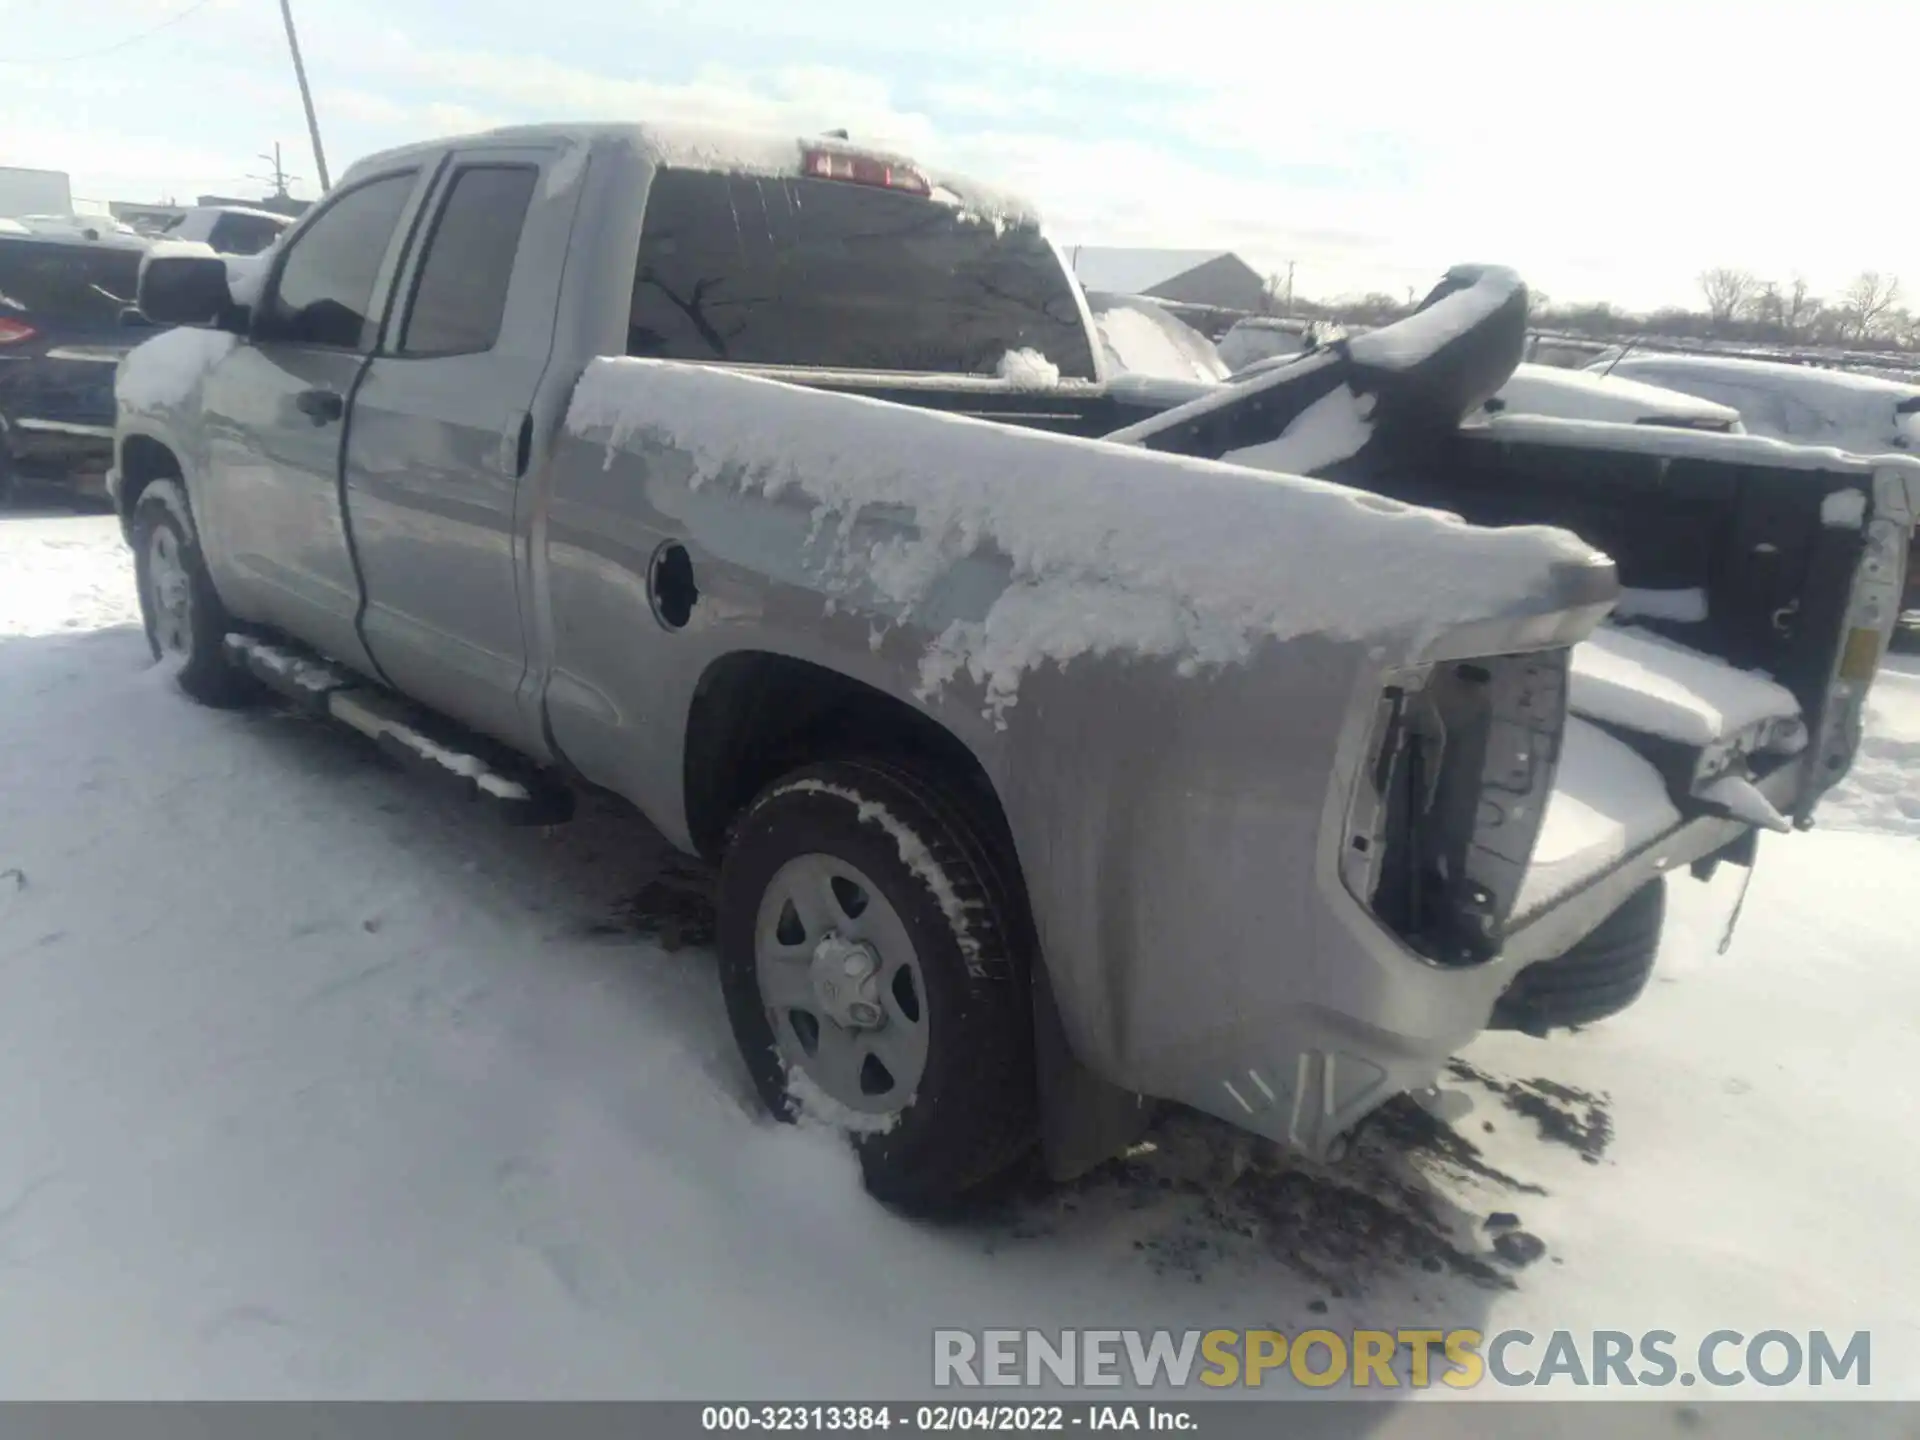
left=541, top=361, right=1611, bottom=1133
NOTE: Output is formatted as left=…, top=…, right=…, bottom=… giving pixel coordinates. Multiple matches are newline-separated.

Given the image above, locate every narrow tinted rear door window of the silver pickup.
left=399, top=165, right=540, bottom=355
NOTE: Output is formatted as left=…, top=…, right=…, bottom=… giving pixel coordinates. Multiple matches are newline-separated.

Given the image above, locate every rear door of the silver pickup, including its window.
left=346, top=146, right=582, bottom=755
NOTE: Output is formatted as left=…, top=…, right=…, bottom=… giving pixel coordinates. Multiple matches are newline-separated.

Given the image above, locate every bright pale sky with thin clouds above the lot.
left=0, top=0, right=1920, bottom=305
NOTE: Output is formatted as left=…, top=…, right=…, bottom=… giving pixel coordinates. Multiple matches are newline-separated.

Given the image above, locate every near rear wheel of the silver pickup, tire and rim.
left=718, top=760, right=1037, bottom=1212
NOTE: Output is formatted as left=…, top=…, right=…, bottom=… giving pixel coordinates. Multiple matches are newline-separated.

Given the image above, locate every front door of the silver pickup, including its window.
left=194, top=165, right=424, bottom=670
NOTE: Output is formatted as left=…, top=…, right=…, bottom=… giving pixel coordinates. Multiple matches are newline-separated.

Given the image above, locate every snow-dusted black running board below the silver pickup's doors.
left=225, top=634, right=574, bottom=826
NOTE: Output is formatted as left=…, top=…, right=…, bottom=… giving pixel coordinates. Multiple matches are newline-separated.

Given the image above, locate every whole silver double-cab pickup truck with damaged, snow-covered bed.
left=111, top=127, right=1920, bottom=1206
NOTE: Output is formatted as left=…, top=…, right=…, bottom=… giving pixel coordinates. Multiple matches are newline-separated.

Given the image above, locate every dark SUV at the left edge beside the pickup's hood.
left=0, top=234, right=154, bottom=499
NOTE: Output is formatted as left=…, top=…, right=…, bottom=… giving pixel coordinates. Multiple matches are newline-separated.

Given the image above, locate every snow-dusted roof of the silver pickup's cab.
left=337, top=121, right=1041, bottom=227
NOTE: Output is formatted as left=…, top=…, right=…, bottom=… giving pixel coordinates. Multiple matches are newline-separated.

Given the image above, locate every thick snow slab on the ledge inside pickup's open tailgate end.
left=1569, top=626, right=1805, bottom=749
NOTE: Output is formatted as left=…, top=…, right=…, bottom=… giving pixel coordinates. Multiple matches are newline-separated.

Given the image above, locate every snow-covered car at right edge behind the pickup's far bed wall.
left=1590, top=351, right=1920, bottom=634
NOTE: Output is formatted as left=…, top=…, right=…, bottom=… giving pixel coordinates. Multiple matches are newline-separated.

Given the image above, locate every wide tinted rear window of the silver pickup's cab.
left=628, top=169, right=1094, bottom=378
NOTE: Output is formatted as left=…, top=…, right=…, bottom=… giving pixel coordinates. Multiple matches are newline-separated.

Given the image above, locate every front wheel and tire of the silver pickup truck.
left=131, top=480, right=261, bottom=708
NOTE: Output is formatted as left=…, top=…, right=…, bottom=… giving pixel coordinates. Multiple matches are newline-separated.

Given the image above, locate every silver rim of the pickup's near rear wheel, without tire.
left=753, top=854, right=927, bottom=1116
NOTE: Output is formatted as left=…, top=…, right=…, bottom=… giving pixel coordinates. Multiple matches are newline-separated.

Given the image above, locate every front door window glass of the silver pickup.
left=257, top=171, right=413, bottom=349
